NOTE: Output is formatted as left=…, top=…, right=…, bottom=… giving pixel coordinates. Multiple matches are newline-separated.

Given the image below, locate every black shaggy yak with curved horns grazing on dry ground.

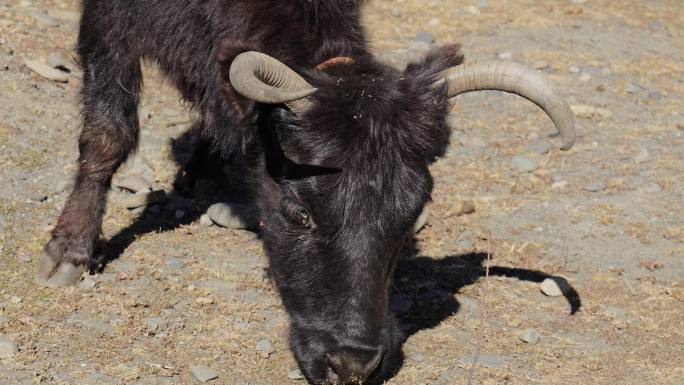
left=36, top=0, right=575, bottom=384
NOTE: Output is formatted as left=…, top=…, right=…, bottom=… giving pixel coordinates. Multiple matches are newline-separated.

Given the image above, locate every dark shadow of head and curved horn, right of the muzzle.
left=377, top=243, right=582, bottom=384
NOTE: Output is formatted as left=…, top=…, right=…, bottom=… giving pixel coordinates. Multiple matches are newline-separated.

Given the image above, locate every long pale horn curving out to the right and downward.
left=435, top=62, right=576, bottom=150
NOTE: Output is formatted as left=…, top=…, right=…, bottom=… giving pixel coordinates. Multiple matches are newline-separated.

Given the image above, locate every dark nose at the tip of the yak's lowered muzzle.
left=325, top=347, right=382, bottom=385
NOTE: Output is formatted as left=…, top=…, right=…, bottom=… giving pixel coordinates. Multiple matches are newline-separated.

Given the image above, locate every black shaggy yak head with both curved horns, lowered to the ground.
left=216, top=45, right=574, bottom=384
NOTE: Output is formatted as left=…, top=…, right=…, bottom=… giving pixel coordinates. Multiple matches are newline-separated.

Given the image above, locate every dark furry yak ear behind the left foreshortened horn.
left=215, top=38, right=259, bottom=117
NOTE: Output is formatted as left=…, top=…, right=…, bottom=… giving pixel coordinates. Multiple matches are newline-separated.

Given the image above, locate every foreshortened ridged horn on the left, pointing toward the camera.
left=229, top=51, right=316, bottom=114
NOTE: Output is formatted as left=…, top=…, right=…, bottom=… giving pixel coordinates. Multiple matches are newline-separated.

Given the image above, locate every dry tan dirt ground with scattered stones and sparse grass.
left=0, top=0, right=684, bottom=385
